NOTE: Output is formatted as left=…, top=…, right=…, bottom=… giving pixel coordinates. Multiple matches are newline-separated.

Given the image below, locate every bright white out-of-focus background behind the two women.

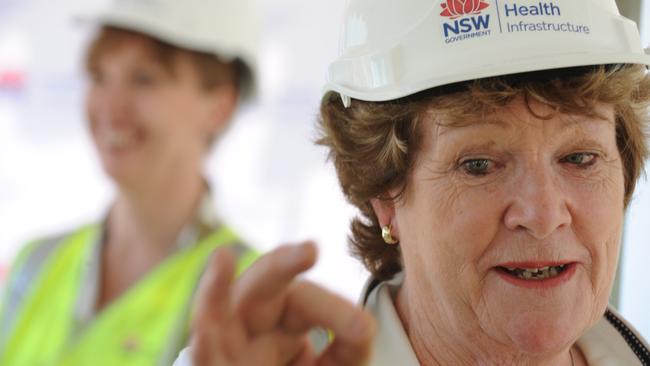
left=0, top=0, right=650, bottom=337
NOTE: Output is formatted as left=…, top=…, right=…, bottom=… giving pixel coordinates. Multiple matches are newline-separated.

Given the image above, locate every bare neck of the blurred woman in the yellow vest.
left=95, top=173, right=206, bottom=311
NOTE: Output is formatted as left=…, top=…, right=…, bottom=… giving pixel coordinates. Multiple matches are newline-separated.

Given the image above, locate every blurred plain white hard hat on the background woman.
left=99, top=0, right=259, bottom=101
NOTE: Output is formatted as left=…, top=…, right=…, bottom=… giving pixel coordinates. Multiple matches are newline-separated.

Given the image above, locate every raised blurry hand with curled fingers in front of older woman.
left=191, top=243, right=375, bottom=366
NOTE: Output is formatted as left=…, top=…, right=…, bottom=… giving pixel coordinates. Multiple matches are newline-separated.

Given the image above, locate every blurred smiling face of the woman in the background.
left=87, top=37, right=224, bottom=186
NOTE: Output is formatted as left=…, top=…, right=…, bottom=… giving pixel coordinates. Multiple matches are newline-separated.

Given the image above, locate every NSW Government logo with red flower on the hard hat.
left=440, top=0, right=491, bottom=43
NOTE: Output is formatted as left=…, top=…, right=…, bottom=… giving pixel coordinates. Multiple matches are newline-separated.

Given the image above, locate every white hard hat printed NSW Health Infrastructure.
left=325, top=0, right=650, bottom=106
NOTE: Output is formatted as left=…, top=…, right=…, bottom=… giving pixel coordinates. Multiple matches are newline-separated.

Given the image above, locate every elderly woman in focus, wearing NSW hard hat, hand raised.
left=176, top=0, right=650, bottom=366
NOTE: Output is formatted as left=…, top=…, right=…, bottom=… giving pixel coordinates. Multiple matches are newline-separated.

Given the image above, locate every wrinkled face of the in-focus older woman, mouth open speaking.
left=392, top=101, right=624, bottom=354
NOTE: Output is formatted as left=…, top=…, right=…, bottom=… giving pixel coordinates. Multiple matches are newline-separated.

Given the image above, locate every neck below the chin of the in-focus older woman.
left=394, top=281, right=576, bottom=366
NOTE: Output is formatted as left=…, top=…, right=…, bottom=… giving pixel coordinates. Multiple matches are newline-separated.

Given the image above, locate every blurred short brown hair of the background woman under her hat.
left=86, top=26, right=249, bottom=91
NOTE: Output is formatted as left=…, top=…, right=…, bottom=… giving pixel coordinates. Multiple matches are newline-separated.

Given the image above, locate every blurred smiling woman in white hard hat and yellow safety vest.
left=0, top=0, right=255, bottom=366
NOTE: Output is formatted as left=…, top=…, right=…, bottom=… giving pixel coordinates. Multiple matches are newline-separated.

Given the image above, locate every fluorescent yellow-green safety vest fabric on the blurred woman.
left=0, top=226, right=256, bottom=366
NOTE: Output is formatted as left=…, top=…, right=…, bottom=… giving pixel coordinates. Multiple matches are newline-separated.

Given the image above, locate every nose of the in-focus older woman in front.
left=504, top=167, right=571, bottom=239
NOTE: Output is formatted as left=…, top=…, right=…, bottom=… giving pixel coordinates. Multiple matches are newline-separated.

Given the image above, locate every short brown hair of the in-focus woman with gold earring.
left=318, top=65, right=650, bottom=280
